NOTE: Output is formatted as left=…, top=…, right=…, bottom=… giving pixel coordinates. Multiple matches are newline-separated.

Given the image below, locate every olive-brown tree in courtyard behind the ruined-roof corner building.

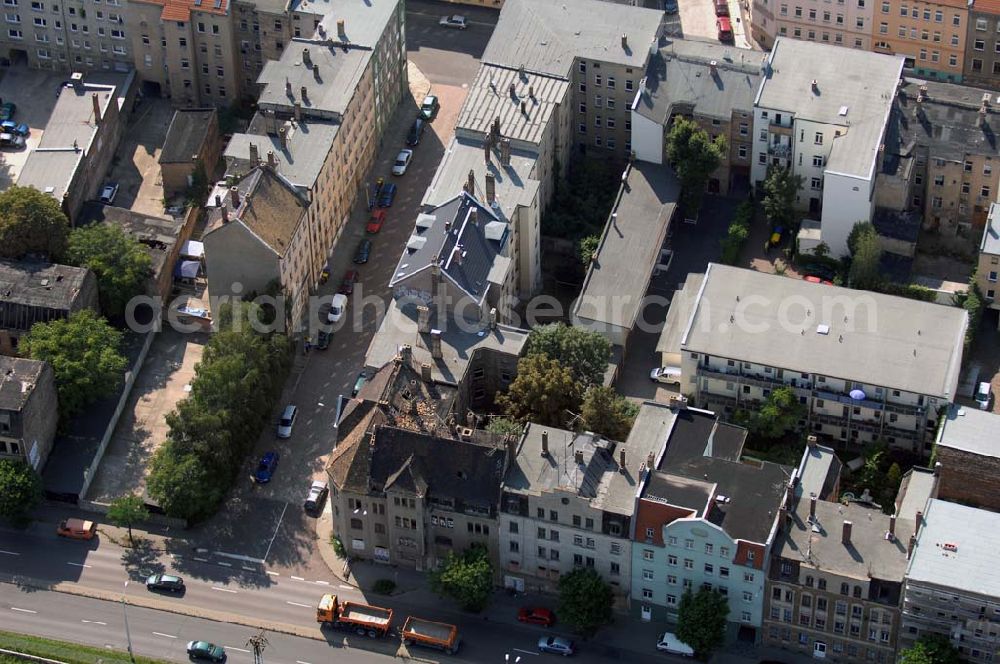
left=497, top=355, right=582, bottom=427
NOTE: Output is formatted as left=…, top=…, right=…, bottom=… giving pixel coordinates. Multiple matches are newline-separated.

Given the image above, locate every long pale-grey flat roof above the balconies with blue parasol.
left=681, top=263, right=968, bottom=400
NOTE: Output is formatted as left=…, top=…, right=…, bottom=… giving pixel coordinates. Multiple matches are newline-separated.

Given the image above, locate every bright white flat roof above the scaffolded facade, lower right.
left=906, top=499, right=1000, bottom=597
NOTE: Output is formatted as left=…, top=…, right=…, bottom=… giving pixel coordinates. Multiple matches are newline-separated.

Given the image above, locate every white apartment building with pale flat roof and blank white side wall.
left=751, top=37, right=903, bottom=256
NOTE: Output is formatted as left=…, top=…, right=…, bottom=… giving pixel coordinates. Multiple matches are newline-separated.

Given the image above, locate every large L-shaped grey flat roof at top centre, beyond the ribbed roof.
left=482, top=0, right=663, bottom=79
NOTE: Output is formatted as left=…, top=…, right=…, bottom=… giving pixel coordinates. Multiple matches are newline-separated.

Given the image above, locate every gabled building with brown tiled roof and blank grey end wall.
left=202, top=165, right=315, bottom=320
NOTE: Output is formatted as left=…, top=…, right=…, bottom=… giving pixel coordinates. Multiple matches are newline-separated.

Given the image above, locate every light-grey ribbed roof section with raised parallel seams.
left=455, top=63, right=569, bottom=145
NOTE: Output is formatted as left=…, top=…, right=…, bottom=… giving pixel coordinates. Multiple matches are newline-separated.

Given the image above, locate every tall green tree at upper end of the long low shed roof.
left=667, top=117, right=726, bottom=216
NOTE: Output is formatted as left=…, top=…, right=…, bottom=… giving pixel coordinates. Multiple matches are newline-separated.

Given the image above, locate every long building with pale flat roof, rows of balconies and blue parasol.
left=663, top=263, right=968, bottom=454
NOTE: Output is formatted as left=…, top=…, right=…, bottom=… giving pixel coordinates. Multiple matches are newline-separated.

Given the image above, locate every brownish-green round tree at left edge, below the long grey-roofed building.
left=0, top=187, right=69, bottom=260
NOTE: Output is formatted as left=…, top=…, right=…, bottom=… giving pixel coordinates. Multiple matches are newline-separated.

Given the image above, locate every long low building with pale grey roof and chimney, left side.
left=17, top=72, right=130, bottom=224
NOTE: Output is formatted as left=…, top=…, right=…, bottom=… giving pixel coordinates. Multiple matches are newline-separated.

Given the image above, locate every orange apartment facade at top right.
left=872, top=0, right=969, bottom=83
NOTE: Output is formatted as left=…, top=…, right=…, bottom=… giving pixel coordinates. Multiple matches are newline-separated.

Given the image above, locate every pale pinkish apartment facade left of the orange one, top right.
left=750, top=0, right=876, bottom=51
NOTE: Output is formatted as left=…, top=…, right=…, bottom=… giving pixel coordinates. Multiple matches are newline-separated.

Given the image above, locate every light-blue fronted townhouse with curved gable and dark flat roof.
left=629, top=401, right=793, bottom=642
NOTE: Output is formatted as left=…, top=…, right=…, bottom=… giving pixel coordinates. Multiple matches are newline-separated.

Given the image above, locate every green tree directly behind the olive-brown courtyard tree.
left=524, top=323, right=611, bottom=386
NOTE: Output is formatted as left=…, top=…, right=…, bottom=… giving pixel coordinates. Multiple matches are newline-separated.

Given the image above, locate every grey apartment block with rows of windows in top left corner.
left=0, top=0, right=132, bottom=72
